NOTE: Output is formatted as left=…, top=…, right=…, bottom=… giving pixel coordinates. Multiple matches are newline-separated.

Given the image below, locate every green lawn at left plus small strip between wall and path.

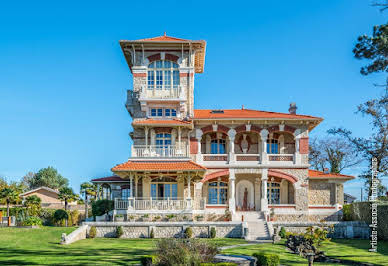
left=0, top=227, right=246, bottom=265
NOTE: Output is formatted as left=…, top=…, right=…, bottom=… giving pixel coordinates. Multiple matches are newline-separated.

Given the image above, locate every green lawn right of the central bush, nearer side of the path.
left=223, top=239, right=388, bottom=266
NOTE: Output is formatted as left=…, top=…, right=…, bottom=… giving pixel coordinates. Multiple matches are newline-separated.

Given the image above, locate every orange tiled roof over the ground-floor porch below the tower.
left=112, top=161, right=206, bottom=172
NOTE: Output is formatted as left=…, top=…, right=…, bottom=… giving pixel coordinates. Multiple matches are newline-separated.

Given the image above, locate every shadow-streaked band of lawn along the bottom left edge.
left=0, top=243, right=151, bottom=265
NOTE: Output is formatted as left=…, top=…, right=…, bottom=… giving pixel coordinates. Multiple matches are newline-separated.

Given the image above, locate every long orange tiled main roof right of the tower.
left=194, top=109, right=323, bottom=120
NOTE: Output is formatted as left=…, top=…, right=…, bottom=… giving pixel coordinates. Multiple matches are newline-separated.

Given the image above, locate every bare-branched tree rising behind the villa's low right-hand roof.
left=309, top=137, right=361, bottom=173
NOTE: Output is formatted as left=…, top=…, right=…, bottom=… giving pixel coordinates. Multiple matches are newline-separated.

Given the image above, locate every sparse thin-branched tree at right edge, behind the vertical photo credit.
left=329, top=92, right=388, bottom=197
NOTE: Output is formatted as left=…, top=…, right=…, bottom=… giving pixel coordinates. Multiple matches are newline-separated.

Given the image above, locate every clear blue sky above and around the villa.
left=0, top=0, right=388, bottom=196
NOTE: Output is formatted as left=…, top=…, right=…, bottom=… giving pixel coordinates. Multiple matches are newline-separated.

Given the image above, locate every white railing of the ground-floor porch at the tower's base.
left=115, top=198, right=206, bottom=211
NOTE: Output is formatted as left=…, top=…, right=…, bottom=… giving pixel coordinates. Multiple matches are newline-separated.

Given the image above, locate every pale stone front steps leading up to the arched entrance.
left=233, top=212, right=271, bottom=242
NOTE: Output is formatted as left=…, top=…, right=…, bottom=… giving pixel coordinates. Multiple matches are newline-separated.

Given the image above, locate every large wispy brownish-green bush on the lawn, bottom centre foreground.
left=156, top=238, right=218, bottom=266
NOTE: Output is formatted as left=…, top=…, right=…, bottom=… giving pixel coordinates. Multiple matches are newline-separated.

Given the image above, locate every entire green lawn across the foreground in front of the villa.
left=0, top=227, right=388, bottom=265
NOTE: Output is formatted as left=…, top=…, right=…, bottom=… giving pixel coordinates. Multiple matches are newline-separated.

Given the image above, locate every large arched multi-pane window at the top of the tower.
left=147, top=60, right=179, bottom=90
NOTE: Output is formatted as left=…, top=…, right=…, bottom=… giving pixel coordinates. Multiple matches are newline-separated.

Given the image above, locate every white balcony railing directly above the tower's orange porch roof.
left=131, top=145, right=190, bottom=158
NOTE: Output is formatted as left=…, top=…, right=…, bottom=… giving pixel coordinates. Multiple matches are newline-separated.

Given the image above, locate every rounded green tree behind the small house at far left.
left=26, top=166, right=69, bottom=189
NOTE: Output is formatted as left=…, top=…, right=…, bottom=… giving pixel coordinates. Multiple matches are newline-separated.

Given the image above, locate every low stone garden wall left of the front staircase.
left=83, top=222, right=243, bottom=238
